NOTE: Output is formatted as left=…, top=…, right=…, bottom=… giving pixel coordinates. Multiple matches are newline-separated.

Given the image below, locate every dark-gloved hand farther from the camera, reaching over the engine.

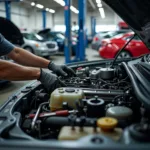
left=48, top=62, right=76, bottom=77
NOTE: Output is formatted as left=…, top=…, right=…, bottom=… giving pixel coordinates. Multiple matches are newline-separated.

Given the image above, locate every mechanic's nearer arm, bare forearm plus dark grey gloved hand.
left=0, top=60, right=59, bottom=92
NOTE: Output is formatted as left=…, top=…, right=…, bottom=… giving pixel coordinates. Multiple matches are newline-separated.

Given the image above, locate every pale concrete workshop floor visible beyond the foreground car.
left=0, top=48, right=101, bottom=104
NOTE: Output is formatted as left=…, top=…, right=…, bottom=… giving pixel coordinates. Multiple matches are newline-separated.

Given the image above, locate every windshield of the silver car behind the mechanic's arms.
left=23, top=33, right=44, bottom=41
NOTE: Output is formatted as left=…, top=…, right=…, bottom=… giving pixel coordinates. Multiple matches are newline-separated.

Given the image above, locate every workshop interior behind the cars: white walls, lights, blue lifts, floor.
left=0, top=0, right=127, bottom=103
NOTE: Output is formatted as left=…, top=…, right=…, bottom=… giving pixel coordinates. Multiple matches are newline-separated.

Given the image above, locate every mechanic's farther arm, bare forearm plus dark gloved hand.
left=8, top=47, right=75, bottom=76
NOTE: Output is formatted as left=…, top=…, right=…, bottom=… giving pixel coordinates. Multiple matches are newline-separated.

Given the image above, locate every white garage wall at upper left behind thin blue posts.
left=0, top=2, right=53, bottom=31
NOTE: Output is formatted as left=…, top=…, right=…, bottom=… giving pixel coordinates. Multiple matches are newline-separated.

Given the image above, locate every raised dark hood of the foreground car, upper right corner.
left=103, top=0, right=150, bottom=49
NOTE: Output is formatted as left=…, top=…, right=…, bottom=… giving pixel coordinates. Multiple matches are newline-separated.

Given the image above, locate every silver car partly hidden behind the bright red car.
left=91, top=30, right=129, bottom=50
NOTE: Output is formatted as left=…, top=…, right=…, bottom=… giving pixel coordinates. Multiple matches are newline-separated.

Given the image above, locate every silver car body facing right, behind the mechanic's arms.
left=22, top=32, right=59, bottom=56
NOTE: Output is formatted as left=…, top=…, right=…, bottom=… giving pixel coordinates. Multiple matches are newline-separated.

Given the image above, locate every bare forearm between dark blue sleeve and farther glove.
left=8, top=47, right=50, bottom=68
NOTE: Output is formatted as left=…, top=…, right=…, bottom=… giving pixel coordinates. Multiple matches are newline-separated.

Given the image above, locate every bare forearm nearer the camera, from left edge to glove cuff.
left=0, top=60, right=41, bottom=81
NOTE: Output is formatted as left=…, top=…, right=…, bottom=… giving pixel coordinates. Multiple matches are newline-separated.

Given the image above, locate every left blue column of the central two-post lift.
left=64, top=0, right=71, bottom=63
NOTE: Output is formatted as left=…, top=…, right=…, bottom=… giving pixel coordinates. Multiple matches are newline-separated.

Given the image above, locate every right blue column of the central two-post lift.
left=78, top=0, right=87, bottom=61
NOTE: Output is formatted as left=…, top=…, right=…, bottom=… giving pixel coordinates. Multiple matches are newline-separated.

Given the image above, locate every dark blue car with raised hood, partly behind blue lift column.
left=38, top=29, right=78, bottom=54
